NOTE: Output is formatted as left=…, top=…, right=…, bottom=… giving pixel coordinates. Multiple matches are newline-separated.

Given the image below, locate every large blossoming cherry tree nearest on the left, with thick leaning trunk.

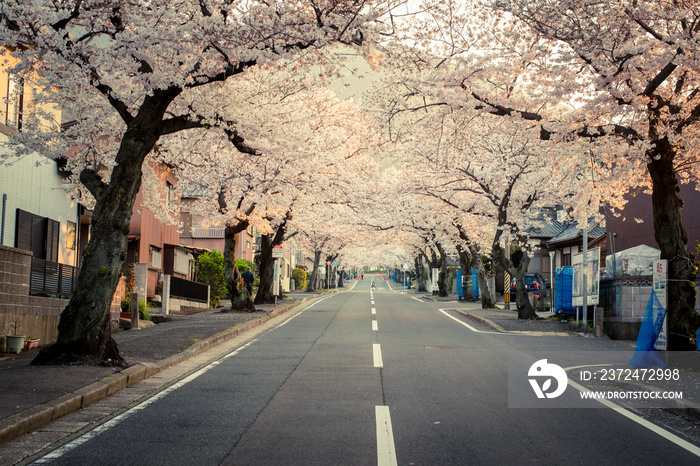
left=0, top=0, right=404, bottom=366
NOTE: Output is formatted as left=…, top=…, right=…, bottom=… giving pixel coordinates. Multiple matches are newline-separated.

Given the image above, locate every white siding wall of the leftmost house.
left=0, top=140, right=80, bottom=265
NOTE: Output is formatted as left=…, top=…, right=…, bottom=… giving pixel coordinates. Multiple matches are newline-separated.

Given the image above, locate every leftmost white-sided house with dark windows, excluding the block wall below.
left=0, top=51, right=85, bottom=295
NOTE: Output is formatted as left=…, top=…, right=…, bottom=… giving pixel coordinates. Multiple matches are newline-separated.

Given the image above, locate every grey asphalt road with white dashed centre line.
left=26, top=277, right=700, bottom=465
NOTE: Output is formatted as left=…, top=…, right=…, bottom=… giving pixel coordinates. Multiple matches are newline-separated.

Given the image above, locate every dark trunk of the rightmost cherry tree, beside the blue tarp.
left=647, top=138, right=700, bottom=351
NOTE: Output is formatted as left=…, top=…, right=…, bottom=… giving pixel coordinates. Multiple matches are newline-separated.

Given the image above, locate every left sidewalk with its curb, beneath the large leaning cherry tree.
left=0, top=291, right=323, bottom=444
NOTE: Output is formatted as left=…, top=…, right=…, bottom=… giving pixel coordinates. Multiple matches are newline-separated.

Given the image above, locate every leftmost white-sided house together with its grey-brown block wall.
left=0, top=51, right=82, bottom=348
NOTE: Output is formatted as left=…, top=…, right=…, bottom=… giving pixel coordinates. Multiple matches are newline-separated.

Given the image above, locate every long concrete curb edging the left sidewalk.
left=0, top=293, right=327, bottom=445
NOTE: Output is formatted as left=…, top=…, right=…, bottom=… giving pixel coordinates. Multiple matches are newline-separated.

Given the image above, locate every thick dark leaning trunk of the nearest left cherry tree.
left=32, top=90, right=179, bottom=367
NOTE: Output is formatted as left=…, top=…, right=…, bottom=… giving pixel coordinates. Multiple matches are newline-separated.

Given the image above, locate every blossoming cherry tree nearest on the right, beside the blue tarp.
left=388, top=0, right=700, bottom=349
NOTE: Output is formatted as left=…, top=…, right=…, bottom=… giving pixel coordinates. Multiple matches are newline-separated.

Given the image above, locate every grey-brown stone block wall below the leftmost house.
left=0, top=246, right=68, bottom=352
